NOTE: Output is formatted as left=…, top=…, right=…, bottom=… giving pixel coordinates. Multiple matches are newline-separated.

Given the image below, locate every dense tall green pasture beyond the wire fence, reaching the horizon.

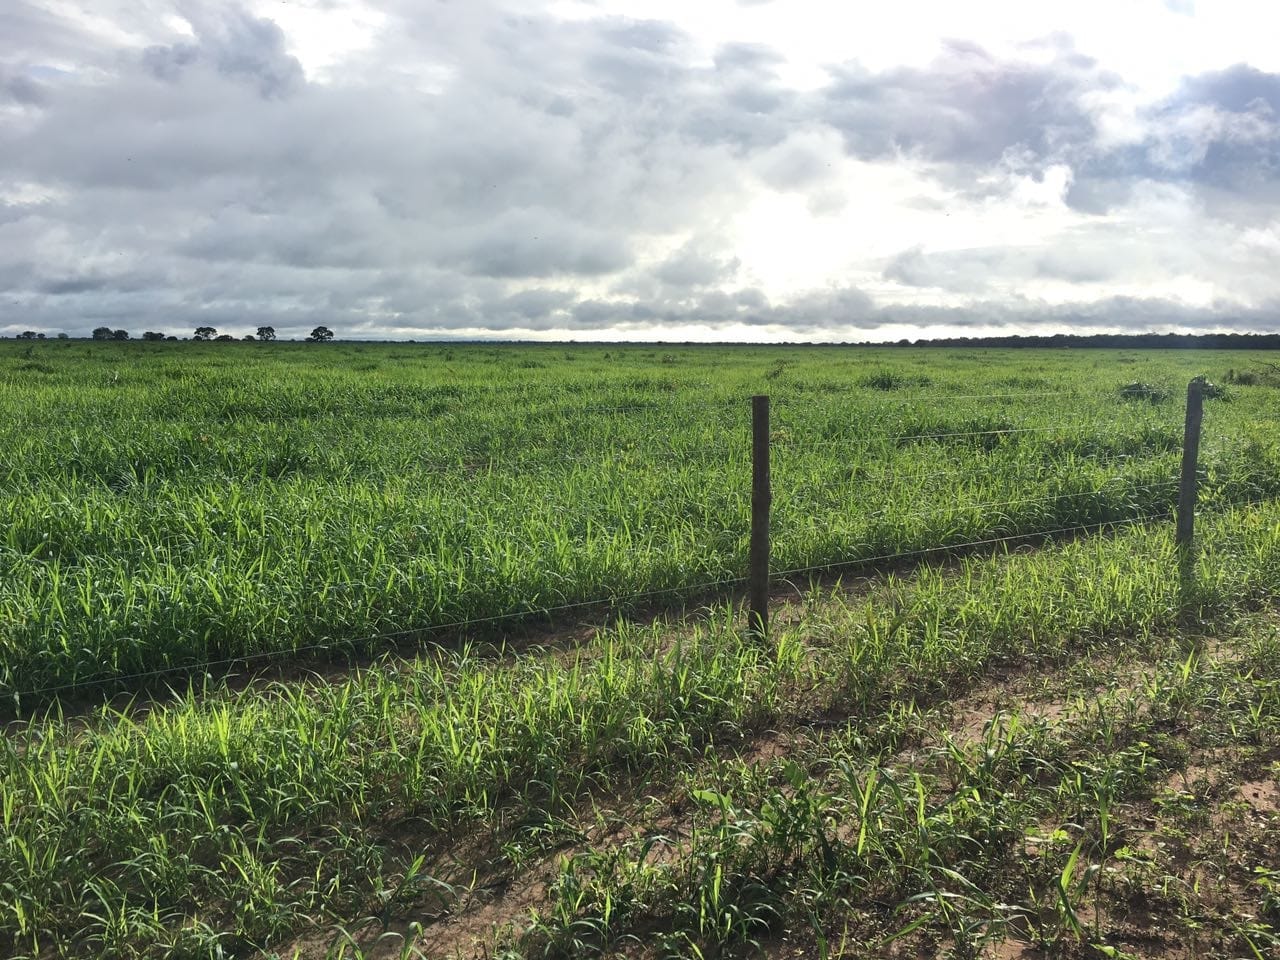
left=0, top=342, right=1280, bottom=709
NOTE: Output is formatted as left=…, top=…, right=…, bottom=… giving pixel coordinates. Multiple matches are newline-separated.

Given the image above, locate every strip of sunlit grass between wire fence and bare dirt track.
left=0, top=507, right=1280, bottom=956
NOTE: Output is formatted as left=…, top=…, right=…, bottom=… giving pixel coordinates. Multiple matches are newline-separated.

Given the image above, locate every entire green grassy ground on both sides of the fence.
left=0, top=342, right=1280, bottom=957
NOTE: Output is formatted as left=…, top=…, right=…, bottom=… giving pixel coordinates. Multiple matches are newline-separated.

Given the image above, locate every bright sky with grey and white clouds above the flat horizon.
left=0, top=0, right=1280, bottom=340
